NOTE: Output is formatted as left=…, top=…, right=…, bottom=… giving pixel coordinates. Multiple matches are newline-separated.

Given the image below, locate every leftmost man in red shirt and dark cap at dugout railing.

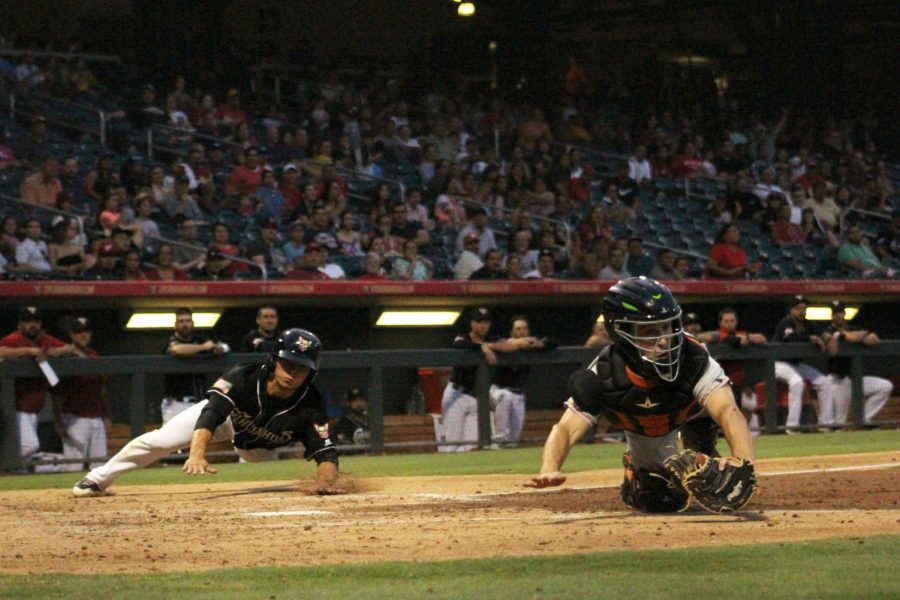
left=0, top=306, right=77, bottom=459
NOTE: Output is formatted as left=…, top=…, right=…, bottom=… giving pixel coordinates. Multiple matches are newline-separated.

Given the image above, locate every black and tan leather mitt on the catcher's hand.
left=665, top=450, right=756, bottom=513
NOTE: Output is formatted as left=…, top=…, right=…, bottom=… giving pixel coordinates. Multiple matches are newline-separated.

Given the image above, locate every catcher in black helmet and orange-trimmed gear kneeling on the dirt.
left=525, top=277, right=756, bottom=512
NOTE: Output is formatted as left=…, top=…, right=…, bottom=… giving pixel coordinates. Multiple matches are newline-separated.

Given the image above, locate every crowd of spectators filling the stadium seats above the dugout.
left=0, top=48, right=900, bottom=280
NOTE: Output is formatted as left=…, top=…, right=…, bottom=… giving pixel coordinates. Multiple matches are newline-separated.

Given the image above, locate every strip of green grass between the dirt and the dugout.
left=0, top=431, right=900, bottom=490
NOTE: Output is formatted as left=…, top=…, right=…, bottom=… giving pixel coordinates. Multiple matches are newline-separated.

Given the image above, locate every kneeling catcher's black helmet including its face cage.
left=602, top=276, right=684, bottom=381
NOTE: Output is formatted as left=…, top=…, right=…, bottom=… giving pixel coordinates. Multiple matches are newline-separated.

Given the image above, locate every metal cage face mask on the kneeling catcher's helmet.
left=613, top=311, right=684, bottom=381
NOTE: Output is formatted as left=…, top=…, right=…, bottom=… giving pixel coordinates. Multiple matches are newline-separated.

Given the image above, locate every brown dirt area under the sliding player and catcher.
left=0, top=452, right=900, bottom=573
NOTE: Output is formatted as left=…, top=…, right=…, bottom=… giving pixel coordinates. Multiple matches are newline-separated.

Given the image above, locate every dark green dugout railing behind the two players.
left=0, top=340, right=900, bottom=471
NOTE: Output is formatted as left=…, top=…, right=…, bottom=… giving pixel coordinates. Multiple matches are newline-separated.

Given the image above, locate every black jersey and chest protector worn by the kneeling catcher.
left=566, top=336, right=729, bottom=437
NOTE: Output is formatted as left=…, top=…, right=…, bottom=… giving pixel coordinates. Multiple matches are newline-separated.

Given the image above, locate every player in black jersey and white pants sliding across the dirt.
left=72, top=329, right=338, bottom=498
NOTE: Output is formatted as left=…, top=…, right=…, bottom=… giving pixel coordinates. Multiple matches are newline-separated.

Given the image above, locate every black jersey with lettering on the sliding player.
left=196, top=363, right=337, bottom=462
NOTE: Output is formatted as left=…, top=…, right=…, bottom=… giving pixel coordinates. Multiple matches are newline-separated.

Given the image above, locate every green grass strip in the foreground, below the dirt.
left=0, top=536, right=900, bottom=600
